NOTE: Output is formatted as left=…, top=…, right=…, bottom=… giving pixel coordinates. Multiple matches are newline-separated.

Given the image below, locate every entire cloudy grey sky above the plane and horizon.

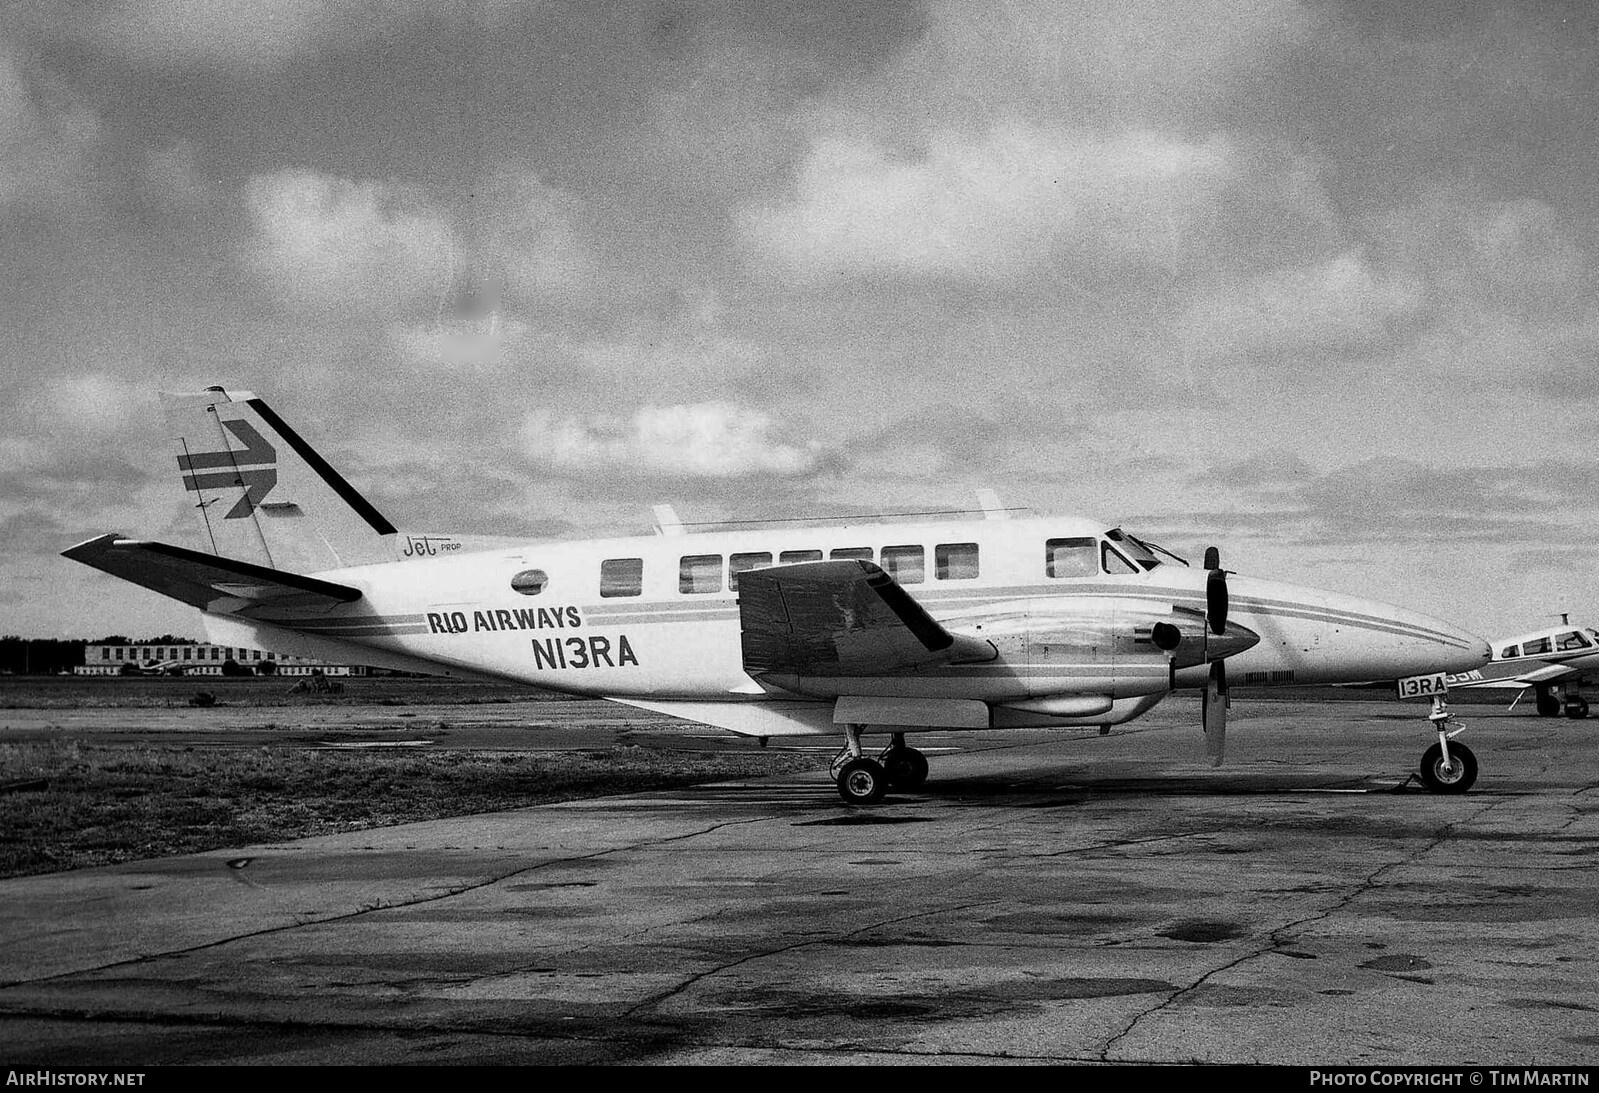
left=0, top=0, right=1599, bottom=636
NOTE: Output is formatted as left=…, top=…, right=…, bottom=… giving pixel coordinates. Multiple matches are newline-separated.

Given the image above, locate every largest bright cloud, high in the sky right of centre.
left=744, top=121, right=1233, bottom=278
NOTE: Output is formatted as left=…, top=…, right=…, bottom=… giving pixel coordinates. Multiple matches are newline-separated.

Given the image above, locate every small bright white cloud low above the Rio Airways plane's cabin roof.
left=521, top=401, right=822, bottom=478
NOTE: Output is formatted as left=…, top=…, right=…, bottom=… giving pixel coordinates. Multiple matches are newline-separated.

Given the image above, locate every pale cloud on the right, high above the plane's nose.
left=1178, top=251, right=1428, bottom=355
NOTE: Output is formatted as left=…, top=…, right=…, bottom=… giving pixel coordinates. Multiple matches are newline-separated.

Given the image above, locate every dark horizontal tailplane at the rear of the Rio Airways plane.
left=61, top=535, right=361, bottom=614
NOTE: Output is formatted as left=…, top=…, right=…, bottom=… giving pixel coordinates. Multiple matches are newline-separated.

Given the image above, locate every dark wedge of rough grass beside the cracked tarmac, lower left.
left=0, top=738, right=825, bottom=877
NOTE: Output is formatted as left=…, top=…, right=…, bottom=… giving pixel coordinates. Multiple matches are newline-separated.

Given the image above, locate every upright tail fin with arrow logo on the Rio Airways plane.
left=163, top=387, right=398, bottom=574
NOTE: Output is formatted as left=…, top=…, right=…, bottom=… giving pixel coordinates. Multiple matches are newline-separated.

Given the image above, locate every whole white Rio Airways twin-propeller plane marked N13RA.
left=62, top=387, right=1489, bottom=805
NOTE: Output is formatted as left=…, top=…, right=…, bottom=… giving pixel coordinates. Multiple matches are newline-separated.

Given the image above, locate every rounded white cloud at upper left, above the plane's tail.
left=245, top=169, right=459, bottom=310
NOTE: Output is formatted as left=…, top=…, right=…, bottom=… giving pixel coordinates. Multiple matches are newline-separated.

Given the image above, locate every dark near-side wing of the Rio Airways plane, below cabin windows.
left=739, top=559, right=998, bottom=686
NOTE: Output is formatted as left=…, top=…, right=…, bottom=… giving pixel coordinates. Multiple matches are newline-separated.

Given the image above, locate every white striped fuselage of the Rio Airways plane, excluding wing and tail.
left=206, top=518, right=1487, bottom=738
